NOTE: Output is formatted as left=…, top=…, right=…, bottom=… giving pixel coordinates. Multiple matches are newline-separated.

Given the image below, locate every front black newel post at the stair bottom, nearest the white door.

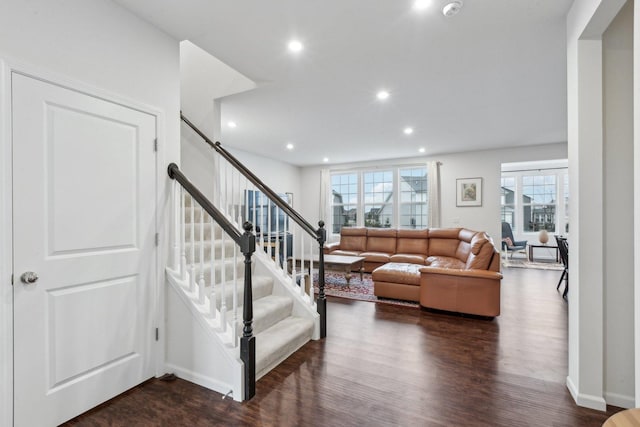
left=240, top=221, right=256, bottom=400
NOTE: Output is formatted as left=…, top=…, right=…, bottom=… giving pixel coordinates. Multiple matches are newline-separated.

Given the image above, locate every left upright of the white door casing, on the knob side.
left=0, top=59, right=13, bottom=426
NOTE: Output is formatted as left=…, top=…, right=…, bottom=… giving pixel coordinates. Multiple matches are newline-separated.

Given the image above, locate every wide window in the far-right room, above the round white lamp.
left=522, top=175, right=557, bottom=232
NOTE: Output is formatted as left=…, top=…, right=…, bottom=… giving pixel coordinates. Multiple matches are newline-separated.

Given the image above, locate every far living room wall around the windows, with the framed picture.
left=301, top=143, right=567, bottom=246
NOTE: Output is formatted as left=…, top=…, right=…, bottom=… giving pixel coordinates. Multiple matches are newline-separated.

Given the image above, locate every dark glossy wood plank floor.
left=67, top=268, right=620, bottom=427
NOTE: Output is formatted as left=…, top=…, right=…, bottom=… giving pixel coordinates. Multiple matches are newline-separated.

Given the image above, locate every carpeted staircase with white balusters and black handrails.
left=164, top=129, right=326, bottom=401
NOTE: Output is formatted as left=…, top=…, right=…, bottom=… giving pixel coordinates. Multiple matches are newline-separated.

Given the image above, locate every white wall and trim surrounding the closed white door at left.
left=0, top=0, right=180, bottom=425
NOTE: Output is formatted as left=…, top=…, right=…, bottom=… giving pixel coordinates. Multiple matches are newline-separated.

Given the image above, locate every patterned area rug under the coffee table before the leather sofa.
left=313, top=271, right=420, bottom=308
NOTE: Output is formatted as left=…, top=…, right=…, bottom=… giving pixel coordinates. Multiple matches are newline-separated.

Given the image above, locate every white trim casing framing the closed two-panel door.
left=0, top=57, right=170, bottom=426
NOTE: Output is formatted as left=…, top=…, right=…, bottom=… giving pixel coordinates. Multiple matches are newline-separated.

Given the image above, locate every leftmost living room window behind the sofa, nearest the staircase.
left=331, top=173, right=358, bottom=233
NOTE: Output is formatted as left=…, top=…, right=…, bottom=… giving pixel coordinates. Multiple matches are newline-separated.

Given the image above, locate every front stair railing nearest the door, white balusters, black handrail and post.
left=168, top=163, right=255, bottom=400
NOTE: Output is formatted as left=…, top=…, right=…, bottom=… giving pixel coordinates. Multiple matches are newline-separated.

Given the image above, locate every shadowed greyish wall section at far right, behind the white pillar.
left=602, top=2, right=635, bottom=407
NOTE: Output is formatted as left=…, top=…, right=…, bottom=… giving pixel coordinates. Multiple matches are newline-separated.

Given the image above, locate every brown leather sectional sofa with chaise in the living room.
left=324, top=227, right=502, bottom=317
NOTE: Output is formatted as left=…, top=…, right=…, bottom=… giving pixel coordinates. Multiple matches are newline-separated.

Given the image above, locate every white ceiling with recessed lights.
left=116, top=0, right=572, bottom=166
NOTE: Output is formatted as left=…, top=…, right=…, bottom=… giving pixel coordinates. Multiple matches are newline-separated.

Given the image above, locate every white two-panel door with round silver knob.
left=12, top=73, right=156, bottom=427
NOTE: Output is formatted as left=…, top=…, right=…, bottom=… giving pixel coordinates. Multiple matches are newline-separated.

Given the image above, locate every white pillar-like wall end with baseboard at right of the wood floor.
left=567, top=0, right=632, bottom=410
